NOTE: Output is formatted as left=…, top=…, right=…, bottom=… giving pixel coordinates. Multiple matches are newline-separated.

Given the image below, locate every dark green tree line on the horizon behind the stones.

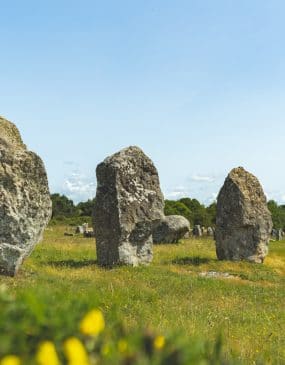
left=51, top=194, right=285, bottom=229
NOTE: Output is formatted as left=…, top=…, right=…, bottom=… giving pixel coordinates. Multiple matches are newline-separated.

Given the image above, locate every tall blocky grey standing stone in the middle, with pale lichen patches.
left=94, top=147, right=164, bottom=266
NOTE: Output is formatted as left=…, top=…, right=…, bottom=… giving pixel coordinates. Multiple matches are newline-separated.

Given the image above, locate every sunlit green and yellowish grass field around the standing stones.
left=0, top=227, right=285, bottom=364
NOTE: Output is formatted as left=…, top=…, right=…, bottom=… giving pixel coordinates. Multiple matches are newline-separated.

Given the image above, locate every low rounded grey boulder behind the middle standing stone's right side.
left=153, top=215, right=190, bottom=243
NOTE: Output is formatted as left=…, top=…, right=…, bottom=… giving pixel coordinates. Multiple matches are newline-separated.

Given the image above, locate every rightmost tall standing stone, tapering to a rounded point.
left=216, top=167, right=272, bottom=263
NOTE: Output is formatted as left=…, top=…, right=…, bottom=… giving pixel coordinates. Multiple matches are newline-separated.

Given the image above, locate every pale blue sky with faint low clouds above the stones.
left=0, top=0, right=285, bottom=204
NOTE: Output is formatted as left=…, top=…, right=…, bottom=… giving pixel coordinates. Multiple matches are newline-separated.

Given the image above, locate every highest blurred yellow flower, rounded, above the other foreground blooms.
left=80, top=309, right=105, bottom=336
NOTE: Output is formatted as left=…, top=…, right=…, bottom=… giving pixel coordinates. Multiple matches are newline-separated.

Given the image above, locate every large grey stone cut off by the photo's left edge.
left=0, top=117, right=51, bottom=276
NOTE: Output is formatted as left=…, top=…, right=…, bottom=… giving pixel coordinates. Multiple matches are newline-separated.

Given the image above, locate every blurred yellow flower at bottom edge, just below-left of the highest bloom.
left=64, top=337, right=90, bottom=365
